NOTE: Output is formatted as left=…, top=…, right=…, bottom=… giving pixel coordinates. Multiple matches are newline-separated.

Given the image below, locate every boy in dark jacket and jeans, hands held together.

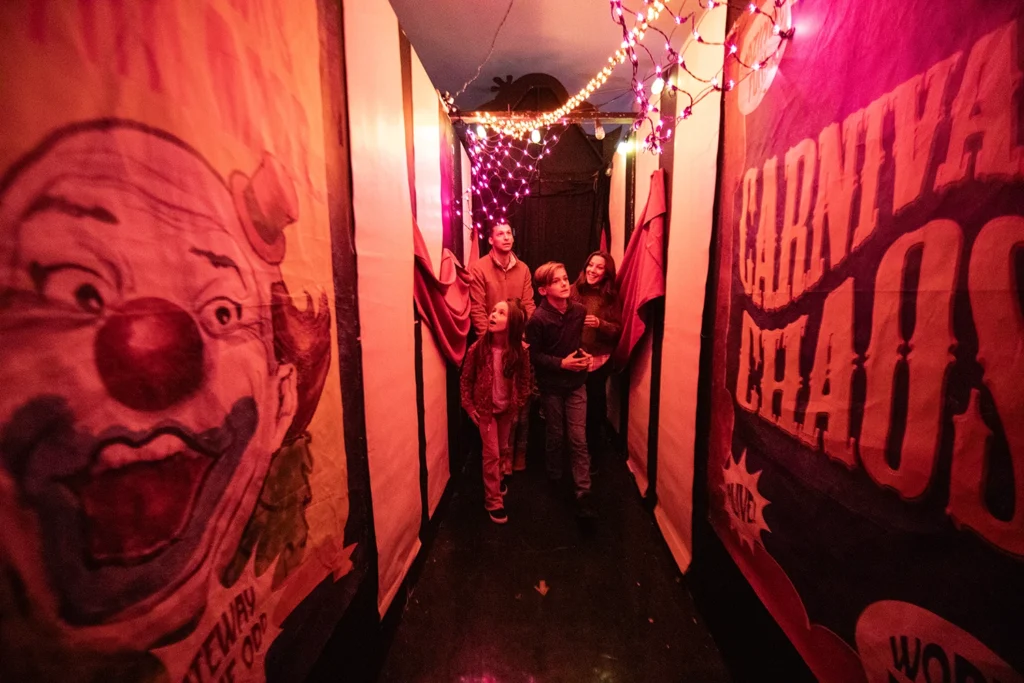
left=526, top=262, right=595, bottom=517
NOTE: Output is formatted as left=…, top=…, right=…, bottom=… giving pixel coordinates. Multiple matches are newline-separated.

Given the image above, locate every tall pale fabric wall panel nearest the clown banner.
left=344, top=0, right=419, bottom=614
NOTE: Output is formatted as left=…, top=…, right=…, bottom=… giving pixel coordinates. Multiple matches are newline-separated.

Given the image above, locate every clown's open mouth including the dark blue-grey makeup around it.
left=0, top=395, right=260, bottom=625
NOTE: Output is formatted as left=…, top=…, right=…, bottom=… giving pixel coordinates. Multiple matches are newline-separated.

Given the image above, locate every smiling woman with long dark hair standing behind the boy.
left=571, top=251, right=623, bottom=472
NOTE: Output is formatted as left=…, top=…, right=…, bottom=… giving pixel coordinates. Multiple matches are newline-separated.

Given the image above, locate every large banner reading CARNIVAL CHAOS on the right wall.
left=708, top=0, right=1024, bottom=683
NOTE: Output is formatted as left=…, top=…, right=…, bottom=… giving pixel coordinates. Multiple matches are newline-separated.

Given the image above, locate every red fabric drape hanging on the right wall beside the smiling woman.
left=612, top=169, right=667, bottom=368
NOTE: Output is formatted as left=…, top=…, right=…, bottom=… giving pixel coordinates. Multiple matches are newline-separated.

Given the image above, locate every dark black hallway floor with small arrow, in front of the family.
left=380, top=438, right=731, bottom=683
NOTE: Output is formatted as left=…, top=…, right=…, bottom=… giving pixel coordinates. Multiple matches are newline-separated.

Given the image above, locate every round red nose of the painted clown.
left=95, top=298, right=203, bottom=411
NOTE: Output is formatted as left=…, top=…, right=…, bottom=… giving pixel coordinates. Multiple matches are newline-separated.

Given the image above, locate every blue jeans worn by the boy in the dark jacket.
left=541, top=386, right=590, bottom=498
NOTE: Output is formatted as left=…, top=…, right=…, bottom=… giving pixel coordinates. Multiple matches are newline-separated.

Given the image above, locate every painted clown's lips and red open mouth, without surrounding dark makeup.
left=65, top=429, right=226, bottom=563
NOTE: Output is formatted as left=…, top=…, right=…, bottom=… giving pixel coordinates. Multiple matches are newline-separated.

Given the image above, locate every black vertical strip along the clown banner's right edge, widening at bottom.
left=303, top=0, right=379, bottom=683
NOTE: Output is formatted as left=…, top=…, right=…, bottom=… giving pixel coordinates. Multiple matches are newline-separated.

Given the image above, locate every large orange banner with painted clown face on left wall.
left=0, top=0, right=364, bottom=682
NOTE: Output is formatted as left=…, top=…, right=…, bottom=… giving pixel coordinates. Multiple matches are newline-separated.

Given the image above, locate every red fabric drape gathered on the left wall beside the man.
left=413, top=222, right=470, bottom=366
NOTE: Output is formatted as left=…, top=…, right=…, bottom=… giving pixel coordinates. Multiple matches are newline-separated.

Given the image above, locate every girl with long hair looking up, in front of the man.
left=461, top=299, right=532, bottom=524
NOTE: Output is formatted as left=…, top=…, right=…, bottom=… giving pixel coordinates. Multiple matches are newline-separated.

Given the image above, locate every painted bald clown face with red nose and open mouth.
left=0, top=125, right=296, bottom=645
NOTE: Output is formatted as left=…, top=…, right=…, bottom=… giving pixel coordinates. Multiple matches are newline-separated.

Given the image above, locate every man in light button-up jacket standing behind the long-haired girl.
left=469, top=221, right=537, bottom=474
